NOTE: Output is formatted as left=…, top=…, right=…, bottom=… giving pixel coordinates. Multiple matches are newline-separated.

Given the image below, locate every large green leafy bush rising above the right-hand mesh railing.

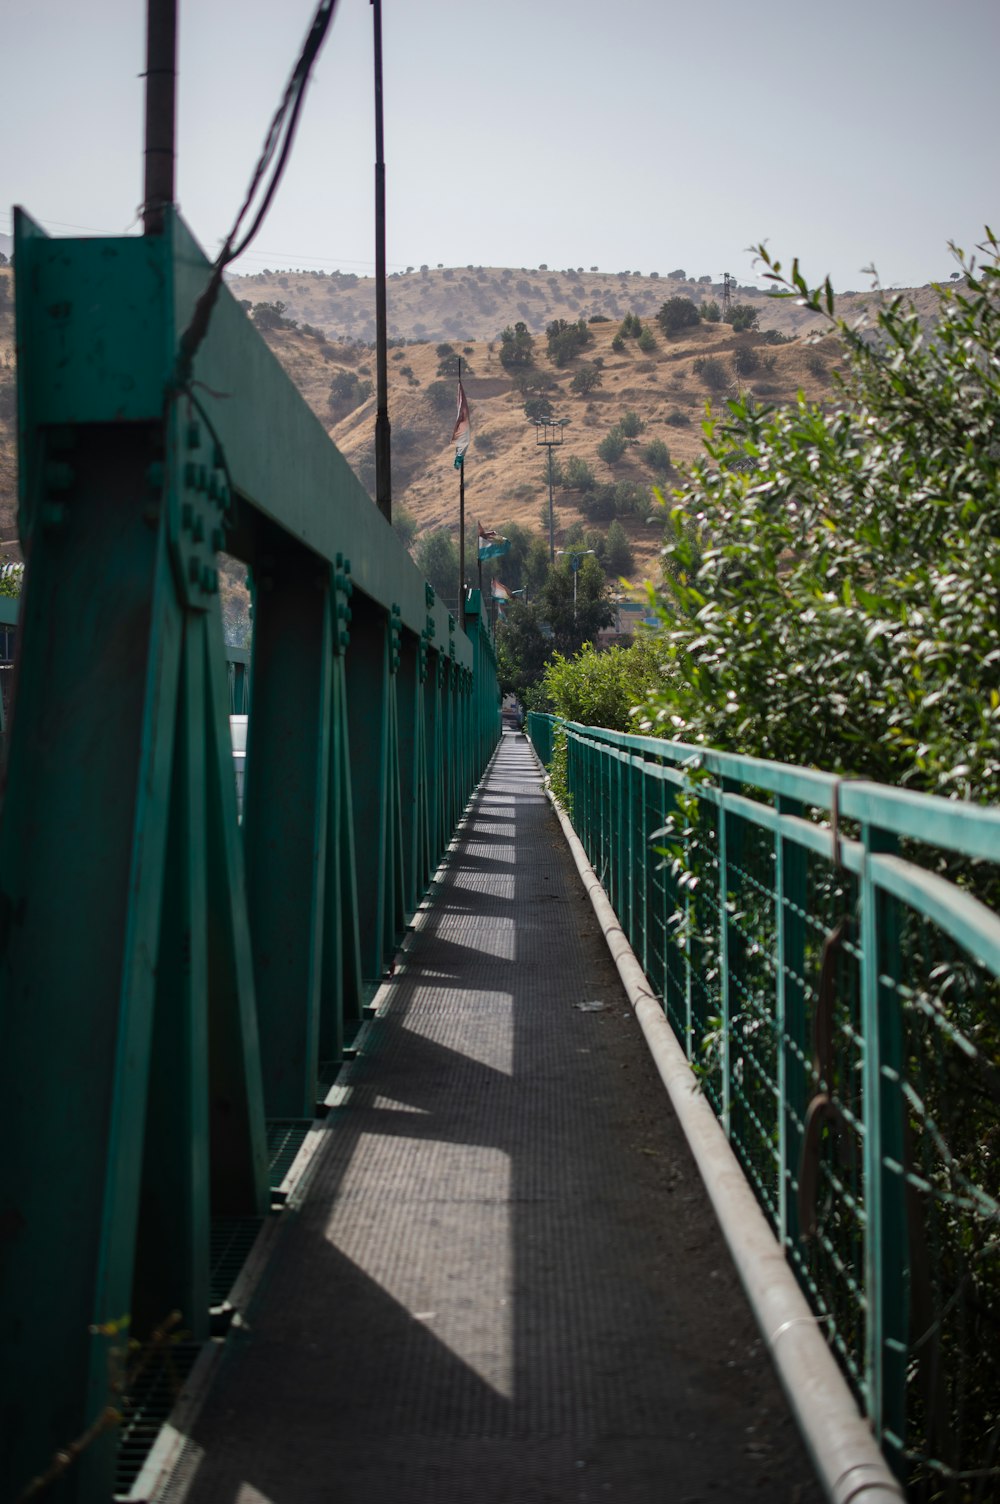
left=647, top=236, right=1000, bottom=802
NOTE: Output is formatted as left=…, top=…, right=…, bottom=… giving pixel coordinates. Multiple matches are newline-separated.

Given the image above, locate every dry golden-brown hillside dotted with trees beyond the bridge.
left=0, top=258, right=950, bottom=578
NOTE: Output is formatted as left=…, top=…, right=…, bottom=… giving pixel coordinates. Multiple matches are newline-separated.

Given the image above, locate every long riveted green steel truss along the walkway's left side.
left=0, top=214, right=499, bottom=1504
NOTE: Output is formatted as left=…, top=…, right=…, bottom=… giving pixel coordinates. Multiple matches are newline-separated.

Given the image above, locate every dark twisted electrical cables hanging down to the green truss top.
left=173, top=0, right=337, bottom=390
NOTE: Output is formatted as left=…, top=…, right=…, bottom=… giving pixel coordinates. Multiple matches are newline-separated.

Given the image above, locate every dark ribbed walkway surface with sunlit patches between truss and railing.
left=179, top=734, right=821, bottom=1504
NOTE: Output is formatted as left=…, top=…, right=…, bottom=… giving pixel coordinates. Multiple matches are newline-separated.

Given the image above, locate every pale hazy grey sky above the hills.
left=0, top=0, right=1000, bottom=289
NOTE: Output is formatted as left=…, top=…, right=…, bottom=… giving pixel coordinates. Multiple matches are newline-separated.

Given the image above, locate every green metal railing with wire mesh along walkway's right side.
left=528, top=714, right=1000, bottom=1504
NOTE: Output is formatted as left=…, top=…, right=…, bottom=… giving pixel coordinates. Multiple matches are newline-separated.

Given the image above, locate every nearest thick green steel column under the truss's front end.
left=0, top=427, right=180, bottom=1498
